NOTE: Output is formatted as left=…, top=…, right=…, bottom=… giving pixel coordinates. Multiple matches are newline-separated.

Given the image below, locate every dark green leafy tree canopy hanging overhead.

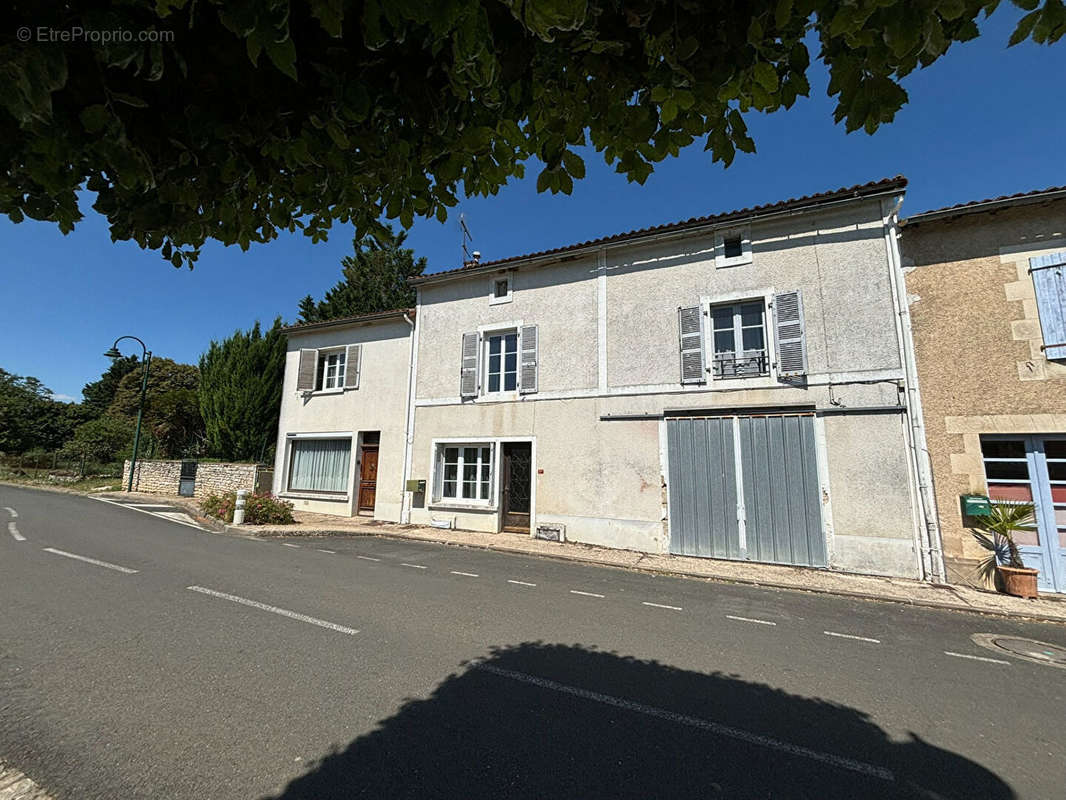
left=0, top=0, right=1066, bottom=267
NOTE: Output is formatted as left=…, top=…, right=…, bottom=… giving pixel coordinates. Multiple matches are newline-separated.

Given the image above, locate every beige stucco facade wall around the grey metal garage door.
left=410, top=201, right=917, bottom=577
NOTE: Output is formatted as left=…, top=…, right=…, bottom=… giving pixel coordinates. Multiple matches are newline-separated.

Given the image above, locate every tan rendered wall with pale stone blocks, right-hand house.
left=901, top=201, right=1066, bottom=582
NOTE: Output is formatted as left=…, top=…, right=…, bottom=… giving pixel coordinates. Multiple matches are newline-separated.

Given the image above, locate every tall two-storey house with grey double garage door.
left=400, top=177, right=942, bottom=580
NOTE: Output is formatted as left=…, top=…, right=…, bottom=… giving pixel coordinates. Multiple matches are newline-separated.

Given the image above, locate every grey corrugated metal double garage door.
left=666, top=414, right=826, bottom=566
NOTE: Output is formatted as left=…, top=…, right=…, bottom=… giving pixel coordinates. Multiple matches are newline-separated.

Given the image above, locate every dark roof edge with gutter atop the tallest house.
left=408, top=175, right=907, bottom=285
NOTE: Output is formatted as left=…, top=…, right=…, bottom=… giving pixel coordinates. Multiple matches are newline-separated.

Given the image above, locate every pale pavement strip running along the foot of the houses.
left=233, top=511, right=1066, bottom=623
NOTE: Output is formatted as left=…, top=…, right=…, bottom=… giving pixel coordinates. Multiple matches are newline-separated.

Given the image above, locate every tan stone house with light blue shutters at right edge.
left=902, top=188, right=1066, bottom=592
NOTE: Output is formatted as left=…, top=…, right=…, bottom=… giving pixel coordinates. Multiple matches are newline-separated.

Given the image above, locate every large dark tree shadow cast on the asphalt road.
left=262, top=643, right=1015, bottom=800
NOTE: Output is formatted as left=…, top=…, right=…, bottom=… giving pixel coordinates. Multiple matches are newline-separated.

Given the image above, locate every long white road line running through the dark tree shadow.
left=474, top=663, right=895, bottom=781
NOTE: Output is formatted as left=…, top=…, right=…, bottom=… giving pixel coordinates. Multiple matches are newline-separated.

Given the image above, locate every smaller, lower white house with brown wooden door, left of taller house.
left=268, top=309, right=415, bottom=522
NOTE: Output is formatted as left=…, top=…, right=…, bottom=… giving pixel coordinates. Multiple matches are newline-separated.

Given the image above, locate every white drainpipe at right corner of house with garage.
left=882, top=195, right=944, bottom=583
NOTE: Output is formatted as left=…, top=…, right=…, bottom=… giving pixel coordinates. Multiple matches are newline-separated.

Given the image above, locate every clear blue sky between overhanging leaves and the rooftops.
left=0, top=4, right=1066, bottom=399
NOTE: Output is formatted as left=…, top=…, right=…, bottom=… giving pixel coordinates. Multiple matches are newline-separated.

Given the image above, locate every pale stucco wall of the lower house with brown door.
left=274, top=319, right=410, bottom=522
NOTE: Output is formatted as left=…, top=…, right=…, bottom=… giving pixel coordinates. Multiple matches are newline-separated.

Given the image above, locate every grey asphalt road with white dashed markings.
left=0, top=485, right=1066, bottom=800
